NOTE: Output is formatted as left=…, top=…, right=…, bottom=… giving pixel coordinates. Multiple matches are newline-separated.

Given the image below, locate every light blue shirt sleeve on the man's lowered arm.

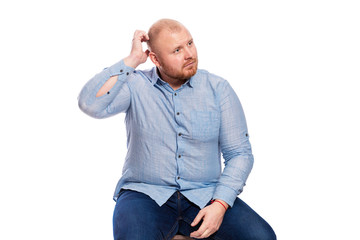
left=213, top=81, right=254, bottom=207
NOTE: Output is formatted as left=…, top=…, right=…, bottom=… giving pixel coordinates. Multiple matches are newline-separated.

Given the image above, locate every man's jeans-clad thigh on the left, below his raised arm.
left=113, top=190, right=178, bottom=240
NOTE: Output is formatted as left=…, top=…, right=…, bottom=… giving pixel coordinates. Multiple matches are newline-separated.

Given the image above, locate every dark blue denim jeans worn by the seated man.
left=113, top=190, right=276, bottom=240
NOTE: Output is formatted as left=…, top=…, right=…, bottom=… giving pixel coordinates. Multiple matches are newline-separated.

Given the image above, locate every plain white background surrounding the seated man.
left=0, top=0, right=360, bottom=240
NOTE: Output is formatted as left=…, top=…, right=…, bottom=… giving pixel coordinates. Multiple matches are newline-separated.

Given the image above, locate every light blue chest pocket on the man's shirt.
left=190, top=111, right=220, bottom=141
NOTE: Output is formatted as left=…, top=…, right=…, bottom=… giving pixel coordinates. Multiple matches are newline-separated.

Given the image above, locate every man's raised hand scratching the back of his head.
left=124, top=30, right=150, bottom=68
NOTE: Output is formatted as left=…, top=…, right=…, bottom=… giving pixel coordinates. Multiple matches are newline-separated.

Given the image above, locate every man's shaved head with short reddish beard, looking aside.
left=148, top=19, right=198, bottom=80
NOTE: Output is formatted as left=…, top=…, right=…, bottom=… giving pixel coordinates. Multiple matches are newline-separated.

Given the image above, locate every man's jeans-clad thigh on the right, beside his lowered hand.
left=212, top=198, right=276, bottom=240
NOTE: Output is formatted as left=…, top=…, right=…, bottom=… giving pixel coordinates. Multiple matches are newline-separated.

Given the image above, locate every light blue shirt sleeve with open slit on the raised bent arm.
left=78, top=60, right=134, bottom=118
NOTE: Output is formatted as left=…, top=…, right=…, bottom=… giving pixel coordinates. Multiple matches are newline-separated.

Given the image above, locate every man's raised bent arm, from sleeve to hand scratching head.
left=78, top=30, right=149, bottom=118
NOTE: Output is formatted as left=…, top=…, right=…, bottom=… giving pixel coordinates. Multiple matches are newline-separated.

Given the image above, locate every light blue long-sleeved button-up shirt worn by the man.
left=78, top=61, right=253, bottom=208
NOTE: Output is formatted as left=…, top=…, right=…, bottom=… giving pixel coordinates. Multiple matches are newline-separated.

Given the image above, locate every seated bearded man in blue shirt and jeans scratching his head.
left=79, top=19, right=276, bottom=240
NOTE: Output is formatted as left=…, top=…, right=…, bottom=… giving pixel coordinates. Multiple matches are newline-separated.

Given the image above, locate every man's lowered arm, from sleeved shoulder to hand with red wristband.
left=190, top=81, right=254, bottom=238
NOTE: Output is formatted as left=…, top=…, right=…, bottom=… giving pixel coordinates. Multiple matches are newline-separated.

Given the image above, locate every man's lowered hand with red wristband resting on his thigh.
left=190, top=200, right=228, bottom=238
